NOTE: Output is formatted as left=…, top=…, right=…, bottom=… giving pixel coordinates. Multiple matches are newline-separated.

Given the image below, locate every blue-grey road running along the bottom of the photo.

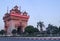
left=0, top=37, right=60, bottom=41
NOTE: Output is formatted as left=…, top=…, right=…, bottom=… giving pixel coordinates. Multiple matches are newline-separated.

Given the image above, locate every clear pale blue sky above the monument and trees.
left=0, top=0, right=60, bottom=29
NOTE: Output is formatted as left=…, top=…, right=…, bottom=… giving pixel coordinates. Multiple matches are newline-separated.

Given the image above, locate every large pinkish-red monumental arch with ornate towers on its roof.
left=3, top=6, right=29, bottom=34
